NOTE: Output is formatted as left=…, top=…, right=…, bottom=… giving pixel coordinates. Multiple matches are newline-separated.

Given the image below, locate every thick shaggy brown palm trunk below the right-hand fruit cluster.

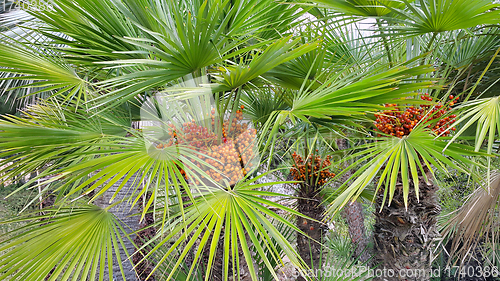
left=374, top=175, right=441, bottom=281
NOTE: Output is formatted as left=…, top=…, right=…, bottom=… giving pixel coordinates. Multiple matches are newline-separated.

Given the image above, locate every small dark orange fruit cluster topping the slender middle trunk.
left=290, top=152, right=335, bottom=186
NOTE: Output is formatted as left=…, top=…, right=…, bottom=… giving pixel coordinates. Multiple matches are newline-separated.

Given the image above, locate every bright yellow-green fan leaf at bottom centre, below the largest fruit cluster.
left=137, top=172, right=304, bottom=280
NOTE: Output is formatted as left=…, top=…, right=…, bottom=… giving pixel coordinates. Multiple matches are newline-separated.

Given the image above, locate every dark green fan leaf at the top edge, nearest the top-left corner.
left=31, top=0, right=146, bottom=63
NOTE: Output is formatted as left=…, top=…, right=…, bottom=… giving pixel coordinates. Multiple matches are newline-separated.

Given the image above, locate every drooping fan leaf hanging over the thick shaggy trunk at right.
left=328, top=127, right=488, bottom=213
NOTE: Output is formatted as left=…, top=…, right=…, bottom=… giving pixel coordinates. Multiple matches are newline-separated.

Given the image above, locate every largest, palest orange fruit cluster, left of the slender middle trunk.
left=156, top=105, right=256, bottom=185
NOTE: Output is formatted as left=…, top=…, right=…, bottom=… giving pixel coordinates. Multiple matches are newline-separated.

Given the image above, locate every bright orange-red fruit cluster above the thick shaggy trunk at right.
left=375, top=94, right=458, bottom=138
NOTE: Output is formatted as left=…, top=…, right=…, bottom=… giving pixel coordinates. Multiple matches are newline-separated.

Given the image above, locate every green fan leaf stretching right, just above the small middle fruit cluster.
left=259, top=63, right=433, bottom=153
